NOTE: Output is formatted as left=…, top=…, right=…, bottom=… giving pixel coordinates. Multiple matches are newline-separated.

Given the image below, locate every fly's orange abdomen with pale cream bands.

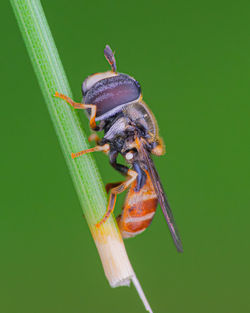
left=117, top=172, right=158, bottom=238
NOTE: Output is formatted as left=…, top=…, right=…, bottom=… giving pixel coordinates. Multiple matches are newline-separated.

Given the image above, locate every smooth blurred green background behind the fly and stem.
left=0, top=0, right=250, bottom=313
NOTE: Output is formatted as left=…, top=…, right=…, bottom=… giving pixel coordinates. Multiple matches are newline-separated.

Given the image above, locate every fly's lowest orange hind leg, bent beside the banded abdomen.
left=95, top=170, right=137, bottom=227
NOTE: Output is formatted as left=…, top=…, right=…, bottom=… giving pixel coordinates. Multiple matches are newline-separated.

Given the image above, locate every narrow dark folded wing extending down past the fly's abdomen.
left=140, top=145, right=183, bottom=252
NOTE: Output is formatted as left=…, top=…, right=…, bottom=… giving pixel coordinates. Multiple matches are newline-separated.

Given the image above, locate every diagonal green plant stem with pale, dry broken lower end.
left=10, top=0, right=151, bottom=312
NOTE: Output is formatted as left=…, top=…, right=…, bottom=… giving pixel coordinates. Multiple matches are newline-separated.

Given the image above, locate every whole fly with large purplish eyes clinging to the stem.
left=55, top=45, right=183, bottom=252
